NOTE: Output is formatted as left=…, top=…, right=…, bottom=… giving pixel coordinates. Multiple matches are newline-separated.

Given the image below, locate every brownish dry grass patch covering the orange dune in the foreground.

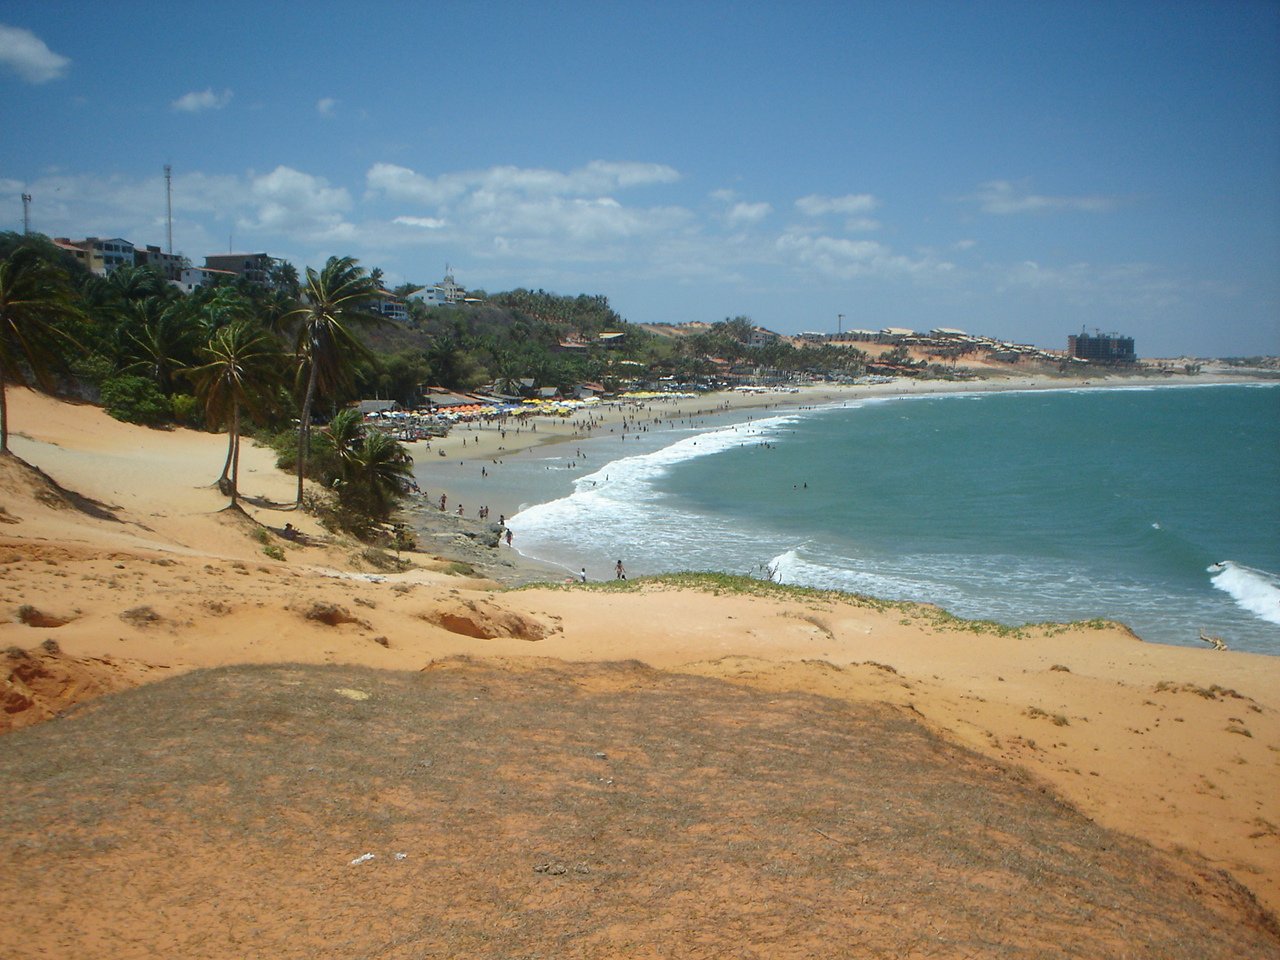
left=0, top=659, right=1280, bottom=960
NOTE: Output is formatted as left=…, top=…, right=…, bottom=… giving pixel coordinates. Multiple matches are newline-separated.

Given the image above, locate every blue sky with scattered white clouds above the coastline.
left=0, top=0, right=1280, bottom=356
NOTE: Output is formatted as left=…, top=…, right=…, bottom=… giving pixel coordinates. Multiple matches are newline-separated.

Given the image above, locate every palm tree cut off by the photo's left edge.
left=0, top=247, right=81, bottom=453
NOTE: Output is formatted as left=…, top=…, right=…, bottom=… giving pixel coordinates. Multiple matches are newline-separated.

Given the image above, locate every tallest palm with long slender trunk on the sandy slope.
left=282, top=257, right=378, bottom=506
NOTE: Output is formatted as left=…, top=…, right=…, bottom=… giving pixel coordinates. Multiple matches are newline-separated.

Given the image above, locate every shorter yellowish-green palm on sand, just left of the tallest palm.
left=183, top=320, right=280, bottom=507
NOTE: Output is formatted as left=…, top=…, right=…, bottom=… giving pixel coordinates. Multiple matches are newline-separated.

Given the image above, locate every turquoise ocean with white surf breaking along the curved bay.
left=509, top=384, right=1280, bottom=654
